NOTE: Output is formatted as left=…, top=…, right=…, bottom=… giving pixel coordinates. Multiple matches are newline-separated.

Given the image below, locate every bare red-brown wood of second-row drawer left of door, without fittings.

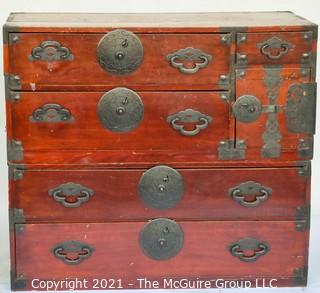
left=11, top=92, right=230, bottom=157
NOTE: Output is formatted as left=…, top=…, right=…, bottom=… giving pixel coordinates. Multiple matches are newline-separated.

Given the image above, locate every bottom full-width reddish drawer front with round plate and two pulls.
left=16, top=219, right=307, bottom=288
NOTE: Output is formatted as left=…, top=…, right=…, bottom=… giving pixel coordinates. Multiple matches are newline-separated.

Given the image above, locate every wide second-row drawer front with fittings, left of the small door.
left=11, top=88, right=230, bottom=161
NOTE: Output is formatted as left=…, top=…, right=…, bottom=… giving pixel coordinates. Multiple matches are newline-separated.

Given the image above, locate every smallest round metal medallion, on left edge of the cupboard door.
left=232, top=95, right=262, bottom=123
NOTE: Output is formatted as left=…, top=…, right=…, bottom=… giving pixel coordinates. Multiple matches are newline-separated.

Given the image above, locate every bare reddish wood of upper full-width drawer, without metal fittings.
left=11, top=168, right=310, bottom=222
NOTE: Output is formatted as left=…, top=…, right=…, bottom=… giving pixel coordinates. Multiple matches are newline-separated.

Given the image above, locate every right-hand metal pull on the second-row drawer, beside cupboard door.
left=167, top=109, right=212, bottom=136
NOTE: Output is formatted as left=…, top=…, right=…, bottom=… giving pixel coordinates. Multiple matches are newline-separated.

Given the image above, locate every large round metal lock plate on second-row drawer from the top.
left=98, top=88, right=144, bottom=132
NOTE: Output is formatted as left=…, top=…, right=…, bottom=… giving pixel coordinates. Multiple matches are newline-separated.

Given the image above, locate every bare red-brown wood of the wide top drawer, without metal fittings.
left=9, top=32, right=230, bottom=91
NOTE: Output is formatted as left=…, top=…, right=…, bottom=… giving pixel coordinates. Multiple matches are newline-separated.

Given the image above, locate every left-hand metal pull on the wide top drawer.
left=29, top=41, right=73, bottom=61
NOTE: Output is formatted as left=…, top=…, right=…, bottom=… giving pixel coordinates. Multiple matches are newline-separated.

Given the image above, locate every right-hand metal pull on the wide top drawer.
left=167, top=47, right=212, bottom=74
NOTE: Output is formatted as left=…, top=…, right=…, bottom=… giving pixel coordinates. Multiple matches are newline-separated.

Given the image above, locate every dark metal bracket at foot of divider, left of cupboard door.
left=218, top=140, right=247, bottom=160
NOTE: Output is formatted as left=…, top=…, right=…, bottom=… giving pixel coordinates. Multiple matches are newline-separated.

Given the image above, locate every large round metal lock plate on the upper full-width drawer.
left=138, top=166, right=184, bottom=210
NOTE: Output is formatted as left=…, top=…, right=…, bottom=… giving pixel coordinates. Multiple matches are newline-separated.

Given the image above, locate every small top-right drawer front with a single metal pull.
left=237, top=31, right=315, bottom=64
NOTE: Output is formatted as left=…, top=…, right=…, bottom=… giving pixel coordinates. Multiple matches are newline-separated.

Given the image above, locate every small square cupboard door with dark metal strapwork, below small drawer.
left=233, top=68, right=316, bottom=160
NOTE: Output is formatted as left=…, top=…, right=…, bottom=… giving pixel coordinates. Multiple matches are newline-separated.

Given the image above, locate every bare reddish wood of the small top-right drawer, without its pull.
left=237, top=31, right=313, bottom=65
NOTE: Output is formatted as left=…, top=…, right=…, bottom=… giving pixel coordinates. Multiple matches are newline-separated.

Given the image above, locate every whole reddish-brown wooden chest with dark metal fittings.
left=3, top=12, right=317, bottom=290
